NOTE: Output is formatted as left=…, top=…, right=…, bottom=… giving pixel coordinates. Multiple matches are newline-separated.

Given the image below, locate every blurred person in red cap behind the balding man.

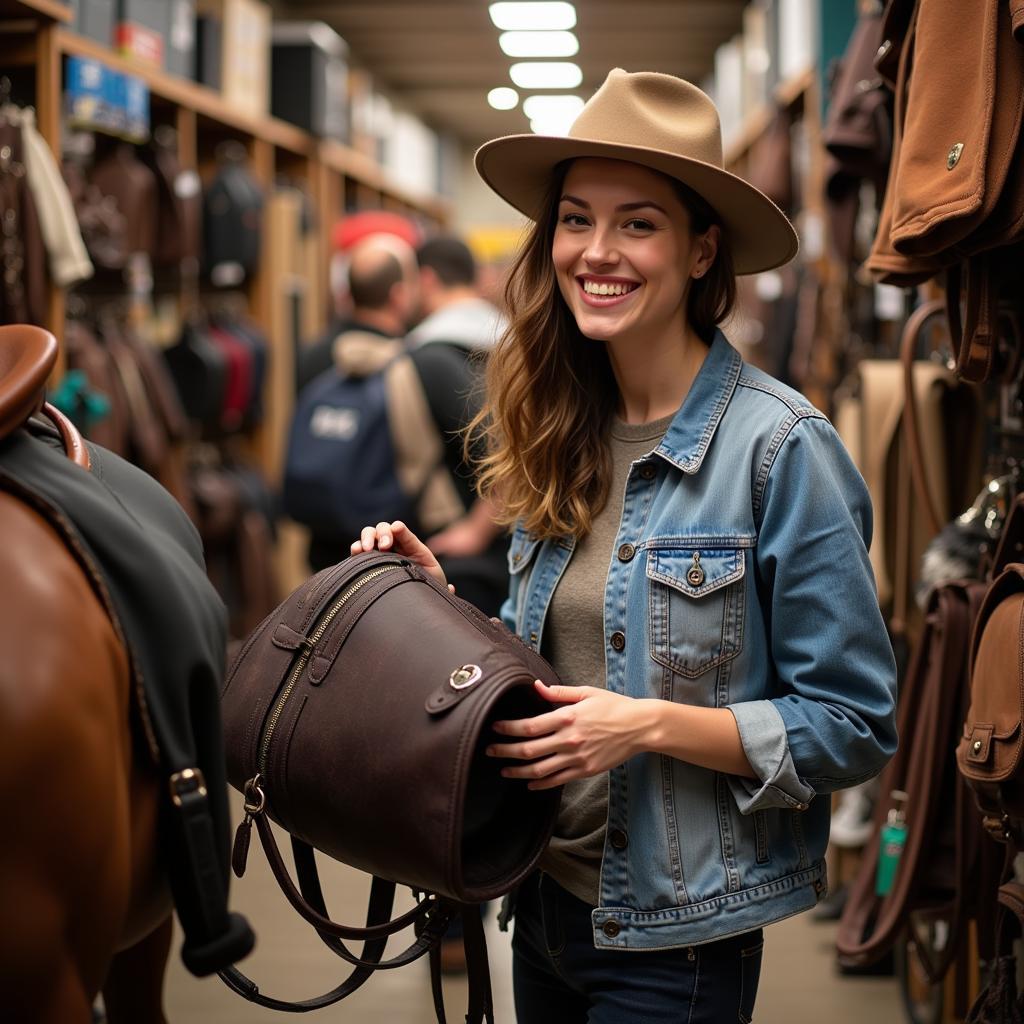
left=295, top=210, right=422, bottom=392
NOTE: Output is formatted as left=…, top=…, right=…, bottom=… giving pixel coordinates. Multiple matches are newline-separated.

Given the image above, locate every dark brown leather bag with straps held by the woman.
left=215, top=552, right=560, bottom=1021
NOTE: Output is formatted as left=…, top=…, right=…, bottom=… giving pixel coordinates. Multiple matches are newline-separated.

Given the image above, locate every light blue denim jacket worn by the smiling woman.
left=502, top=332, right=896, bottom=949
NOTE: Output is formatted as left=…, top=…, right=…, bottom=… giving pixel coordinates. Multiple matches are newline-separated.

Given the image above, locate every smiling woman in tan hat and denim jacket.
left=351, top=70, right=896, bottom=1024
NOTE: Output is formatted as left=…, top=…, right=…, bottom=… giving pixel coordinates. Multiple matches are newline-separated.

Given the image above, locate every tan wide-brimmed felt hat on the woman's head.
left=476, top=68, right=798, bottom=273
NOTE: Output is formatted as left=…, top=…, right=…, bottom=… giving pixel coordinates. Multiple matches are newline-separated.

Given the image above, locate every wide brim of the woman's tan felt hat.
left=474, top=135, right=800, bottom=274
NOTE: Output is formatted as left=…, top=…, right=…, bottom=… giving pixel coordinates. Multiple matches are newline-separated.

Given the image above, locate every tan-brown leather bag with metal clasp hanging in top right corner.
left=866, top=0, right=1024, bottom=382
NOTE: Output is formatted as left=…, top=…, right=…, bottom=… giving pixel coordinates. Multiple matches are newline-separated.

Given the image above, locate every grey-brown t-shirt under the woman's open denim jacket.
left=540, top=407, right=674, bottom=906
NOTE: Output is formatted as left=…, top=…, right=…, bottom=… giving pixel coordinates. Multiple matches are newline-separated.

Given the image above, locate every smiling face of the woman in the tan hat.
left=551, top=158, right=714, bottom=341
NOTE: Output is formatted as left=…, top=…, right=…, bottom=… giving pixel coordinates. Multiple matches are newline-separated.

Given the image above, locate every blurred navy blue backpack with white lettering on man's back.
left=283, top=356, right=420, bottom=542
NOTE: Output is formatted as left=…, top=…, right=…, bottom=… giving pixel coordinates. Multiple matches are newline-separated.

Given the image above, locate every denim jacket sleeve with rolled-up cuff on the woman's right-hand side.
left=729, top=416, right=896, bottom=813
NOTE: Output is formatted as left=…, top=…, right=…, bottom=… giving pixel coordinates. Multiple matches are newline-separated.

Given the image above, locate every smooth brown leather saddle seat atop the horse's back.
left=0, top=324, right=89, bottom=469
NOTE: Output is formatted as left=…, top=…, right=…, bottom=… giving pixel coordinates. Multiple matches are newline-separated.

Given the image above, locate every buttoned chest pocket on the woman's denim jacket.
left=647, top=546, right=745, bottom=679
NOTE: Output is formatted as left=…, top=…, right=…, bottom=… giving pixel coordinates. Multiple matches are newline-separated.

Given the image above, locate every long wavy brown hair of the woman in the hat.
left=467, top=161, right=736, bottom=538
